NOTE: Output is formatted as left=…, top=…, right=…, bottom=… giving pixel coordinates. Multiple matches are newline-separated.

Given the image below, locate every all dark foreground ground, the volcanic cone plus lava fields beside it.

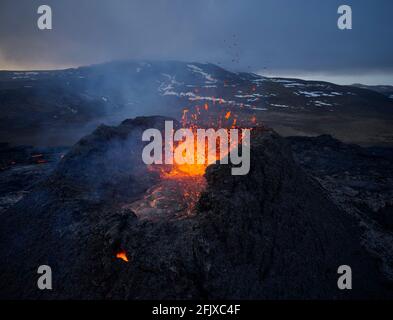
left=0, top=117, right=393, bottom=299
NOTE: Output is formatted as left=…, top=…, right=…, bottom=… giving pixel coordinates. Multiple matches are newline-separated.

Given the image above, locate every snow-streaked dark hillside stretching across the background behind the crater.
left=0, top=61, right=393, bottom=145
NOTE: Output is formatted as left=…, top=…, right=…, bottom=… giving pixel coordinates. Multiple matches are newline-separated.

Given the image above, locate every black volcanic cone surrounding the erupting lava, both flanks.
left=0, top=118, right=392, bottom=299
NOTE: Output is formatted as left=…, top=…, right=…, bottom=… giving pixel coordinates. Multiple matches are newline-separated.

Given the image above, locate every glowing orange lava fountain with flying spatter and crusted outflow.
left=127, top=99, right=256, bottom=221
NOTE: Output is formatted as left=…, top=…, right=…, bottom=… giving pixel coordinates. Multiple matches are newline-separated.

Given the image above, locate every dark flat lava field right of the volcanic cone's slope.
left=287, top=135, right=393, bottom=283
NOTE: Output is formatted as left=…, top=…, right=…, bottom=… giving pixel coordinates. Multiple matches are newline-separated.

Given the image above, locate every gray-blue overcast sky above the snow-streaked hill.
left=0, top=0, right=393, bottom=84
